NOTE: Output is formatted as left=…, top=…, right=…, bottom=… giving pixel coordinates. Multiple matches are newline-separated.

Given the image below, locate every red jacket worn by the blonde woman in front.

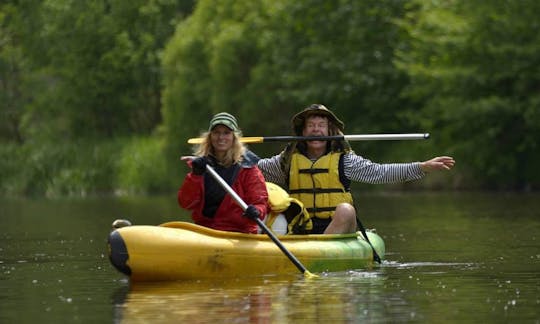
left=178, top=165, right=268, bottom=233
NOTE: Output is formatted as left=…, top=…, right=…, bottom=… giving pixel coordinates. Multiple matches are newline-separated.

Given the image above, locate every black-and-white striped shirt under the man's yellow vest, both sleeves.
left=258, top=152, right=425, bottom=188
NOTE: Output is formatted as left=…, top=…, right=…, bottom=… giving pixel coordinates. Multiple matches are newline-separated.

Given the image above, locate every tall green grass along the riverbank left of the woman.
left=0, top=138, right=171, bottom=197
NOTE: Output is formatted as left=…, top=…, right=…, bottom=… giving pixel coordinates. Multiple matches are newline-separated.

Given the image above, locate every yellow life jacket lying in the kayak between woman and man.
left=266, top=182, right=313, bottom=234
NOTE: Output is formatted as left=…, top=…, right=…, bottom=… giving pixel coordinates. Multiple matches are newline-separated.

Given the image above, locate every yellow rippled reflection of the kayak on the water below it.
left=115, top=271, right=396, bottom=323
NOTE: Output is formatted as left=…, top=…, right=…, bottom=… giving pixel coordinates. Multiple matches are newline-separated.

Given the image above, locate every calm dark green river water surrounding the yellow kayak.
left=0, top=192, right=540, bottom=323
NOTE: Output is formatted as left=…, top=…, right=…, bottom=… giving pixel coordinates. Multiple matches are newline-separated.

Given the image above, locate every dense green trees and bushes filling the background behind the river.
left=0, top=0, right=540, bottom=196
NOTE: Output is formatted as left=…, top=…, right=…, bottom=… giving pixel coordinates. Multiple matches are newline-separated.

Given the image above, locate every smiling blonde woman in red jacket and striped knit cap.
left=178, top=112, right=268, bottom=233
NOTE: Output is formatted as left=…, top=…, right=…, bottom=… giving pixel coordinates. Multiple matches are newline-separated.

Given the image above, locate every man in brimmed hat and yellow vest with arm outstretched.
left=258, top=104, right=455, bottom=234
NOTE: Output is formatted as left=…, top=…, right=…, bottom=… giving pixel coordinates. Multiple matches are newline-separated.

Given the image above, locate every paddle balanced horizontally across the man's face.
left=188, top=133, right=429, bottom=144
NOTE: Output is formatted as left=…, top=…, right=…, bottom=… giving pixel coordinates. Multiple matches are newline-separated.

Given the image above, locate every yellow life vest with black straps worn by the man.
left=289, top=152, right=353, bottom=218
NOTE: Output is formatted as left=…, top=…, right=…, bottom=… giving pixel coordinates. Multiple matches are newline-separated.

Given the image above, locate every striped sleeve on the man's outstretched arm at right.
left=343, top=153, right=425, bottom=184
